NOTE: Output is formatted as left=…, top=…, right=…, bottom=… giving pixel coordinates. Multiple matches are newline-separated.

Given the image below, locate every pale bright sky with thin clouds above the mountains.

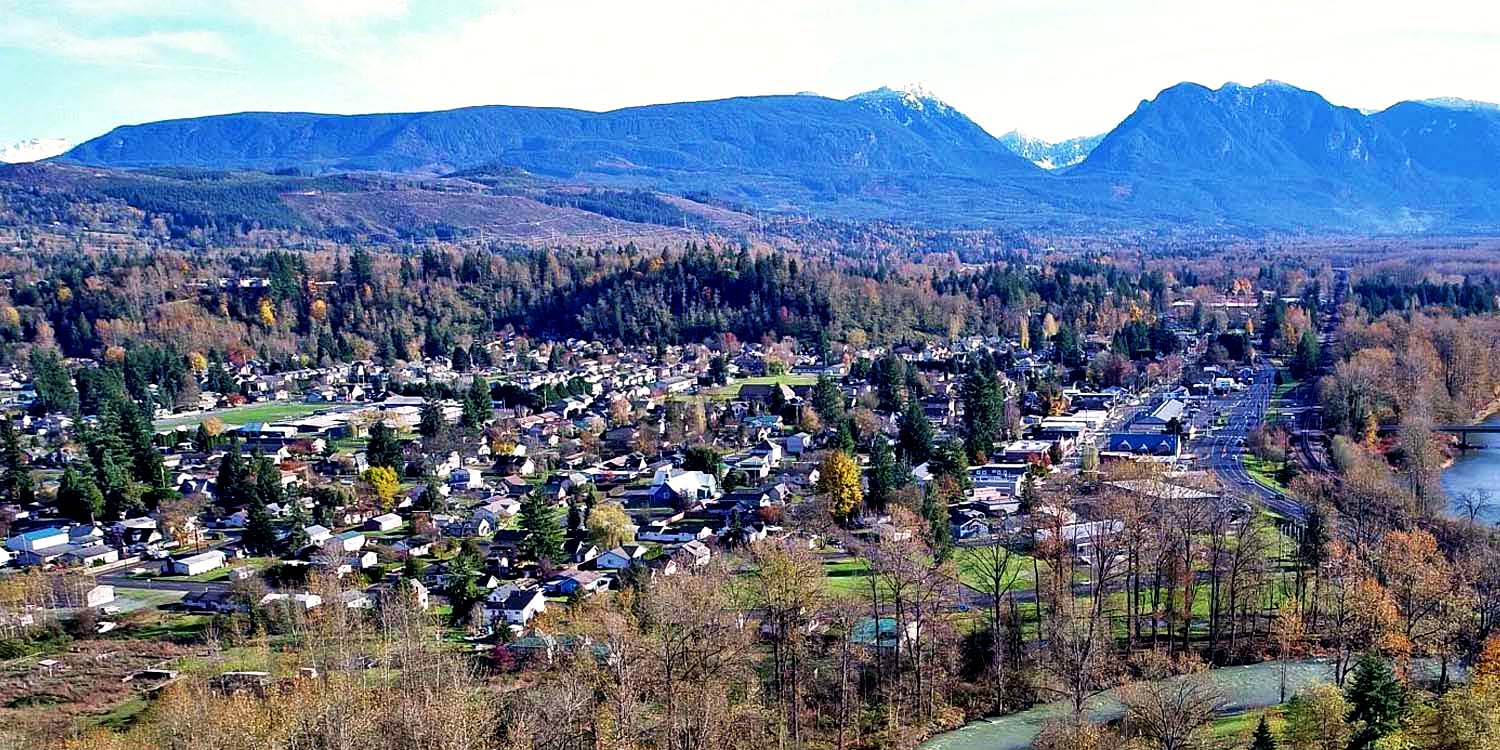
left=0, top=0, right=1500, bottom=146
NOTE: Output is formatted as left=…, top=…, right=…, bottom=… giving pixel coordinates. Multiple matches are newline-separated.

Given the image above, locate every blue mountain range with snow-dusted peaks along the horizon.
left=35, top=81, right=1500, bottom=233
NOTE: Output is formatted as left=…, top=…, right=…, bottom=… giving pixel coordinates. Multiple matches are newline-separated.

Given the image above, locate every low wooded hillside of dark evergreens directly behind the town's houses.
left=0, top=242, right=1194, bottom=375
